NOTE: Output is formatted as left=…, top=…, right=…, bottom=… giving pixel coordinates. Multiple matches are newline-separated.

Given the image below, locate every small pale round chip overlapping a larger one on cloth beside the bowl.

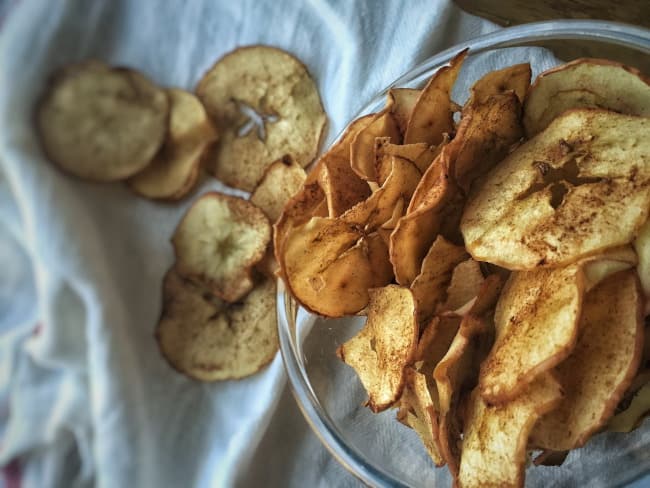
left=172, top=192, right=271, bottom=302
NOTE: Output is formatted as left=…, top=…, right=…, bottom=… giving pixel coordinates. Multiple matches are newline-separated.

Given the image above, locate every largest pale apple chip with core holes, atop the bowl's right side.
left=460, top=110, right=650, bottom=270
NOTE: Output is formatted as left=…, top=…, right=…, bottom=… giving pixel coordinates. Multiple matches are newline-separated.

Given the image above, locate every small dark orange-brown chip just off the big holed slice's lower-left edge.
left=411, top=236, right=467, bottom=324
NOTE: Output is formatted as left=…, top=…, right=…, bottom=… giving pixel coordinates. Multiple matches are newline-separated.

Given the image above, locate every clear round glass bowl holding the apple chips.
left=278, top=20, right=650, bottom=487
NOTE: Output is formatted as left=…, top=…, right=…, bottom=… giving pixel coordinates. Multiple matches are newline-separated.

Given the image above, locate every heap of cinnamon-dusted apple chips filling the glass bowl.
left=274, top=51, right=650, bottom=487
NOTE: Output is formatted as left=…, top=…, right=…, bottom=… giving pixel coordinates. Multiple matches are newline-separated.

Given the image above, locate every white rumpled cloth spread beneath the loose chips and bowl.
left=0, top=0, right=636, bottom=487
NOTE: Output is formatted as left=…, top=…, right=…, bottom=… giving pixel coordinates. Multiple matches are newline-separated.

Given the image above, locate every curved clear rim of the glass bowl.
left=277, top=20, right=650, bottom=487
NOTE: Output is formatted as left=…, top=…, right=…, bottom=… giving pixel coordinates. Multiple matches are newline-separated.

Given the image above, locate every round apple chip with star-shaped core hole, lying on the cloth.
left=196, top=46, right=327, bottom=191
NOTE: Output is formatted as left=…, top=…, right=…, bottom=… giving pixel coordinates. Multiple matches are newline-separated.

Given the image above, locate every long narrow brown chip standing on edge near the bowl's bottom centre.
left=433, top=315, right=494, bottom=476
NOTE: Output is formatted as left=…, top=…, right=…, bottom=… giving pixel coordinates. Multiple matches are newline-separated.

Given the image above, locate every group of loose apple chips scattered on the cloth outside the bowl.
left=36, top=46, right=326, bottom=381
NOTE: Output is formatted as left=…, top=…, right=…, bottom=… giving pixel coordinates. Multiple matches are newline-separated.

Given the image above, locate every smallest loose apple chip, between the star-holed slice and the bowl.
left=250, top=156, right=307, bottom=222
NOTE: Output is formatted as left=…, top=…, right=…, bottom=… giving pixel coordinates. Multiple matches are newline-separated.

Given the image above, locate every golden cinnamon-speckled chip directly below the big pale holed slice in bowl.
left=479, top=265, right=584, bottom=404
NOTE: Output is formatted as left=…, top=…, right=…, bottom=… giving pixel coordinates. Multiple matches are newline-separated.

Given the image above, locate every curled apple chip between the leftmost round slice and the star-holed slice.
left=128, top=88, right=217, bottom=200
